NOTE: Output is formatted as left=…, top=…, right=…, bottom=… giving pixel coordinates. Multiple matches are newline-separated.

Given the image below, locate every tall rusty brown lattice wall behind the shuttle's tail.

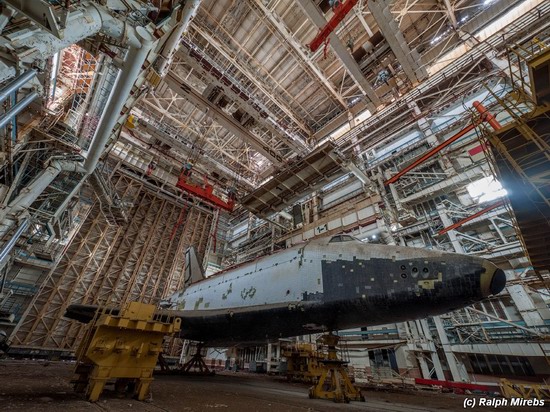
left=12, top=174, right=212, bottom=349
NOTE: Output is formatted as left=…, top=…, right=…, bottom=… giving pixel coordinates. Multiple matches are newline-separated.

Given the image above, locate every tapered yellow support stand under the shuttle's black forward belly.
left=309, top=334, right=365, bottom=402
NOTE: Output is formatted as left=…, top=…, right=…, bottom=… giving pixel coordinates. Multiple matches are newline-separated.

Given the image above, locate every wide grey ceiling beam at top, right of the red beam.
left=368, top=0, right=428, bottom=83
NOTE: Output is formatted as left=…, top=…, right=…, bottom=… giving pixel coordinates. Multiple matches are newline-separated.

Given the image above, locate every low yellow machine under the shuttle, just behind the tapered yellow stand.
left=282, top=342, right=325, bottom=383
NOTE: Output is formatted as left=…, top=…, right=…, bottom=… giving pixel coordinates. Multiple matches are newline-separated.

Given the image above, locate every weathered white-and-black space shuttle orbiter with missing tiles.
left=66, top=235, right=506, bottom=345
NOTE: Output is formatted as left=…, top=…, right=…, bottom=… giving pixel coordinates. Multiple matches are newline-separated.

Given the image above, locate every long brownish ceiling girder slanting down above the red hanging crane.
left=163, top=72, right=284, bottom=165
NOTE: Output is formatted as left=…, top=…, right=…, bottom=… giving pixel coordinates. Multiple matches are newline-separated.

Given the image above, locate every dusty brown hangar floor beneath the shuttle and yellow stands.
left=0, top=359, right=546, bottom=412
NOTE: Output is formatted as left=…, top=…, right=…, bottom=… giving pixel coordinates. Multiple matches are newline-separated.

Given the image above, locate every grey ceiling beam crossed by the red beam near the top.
left=296, top=0, right=380, bottom=109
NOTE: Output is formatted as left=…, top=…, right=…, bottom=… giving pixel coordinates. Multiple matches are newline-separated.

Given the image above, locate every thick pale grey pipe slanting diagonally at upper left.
left=84, top=27, right=155, bottom=173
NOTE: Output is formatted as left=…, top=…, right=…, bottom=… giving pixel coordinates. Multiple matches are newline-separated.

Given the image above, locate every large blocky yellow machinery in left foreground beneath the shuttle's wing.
left=73, top=302, right=181, bottom=402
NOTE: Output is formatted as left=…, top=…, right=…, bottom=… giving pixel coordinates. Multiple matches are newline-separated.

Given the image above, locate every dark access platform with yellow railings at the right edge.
left=483, top=43, right=550, bottom=276
